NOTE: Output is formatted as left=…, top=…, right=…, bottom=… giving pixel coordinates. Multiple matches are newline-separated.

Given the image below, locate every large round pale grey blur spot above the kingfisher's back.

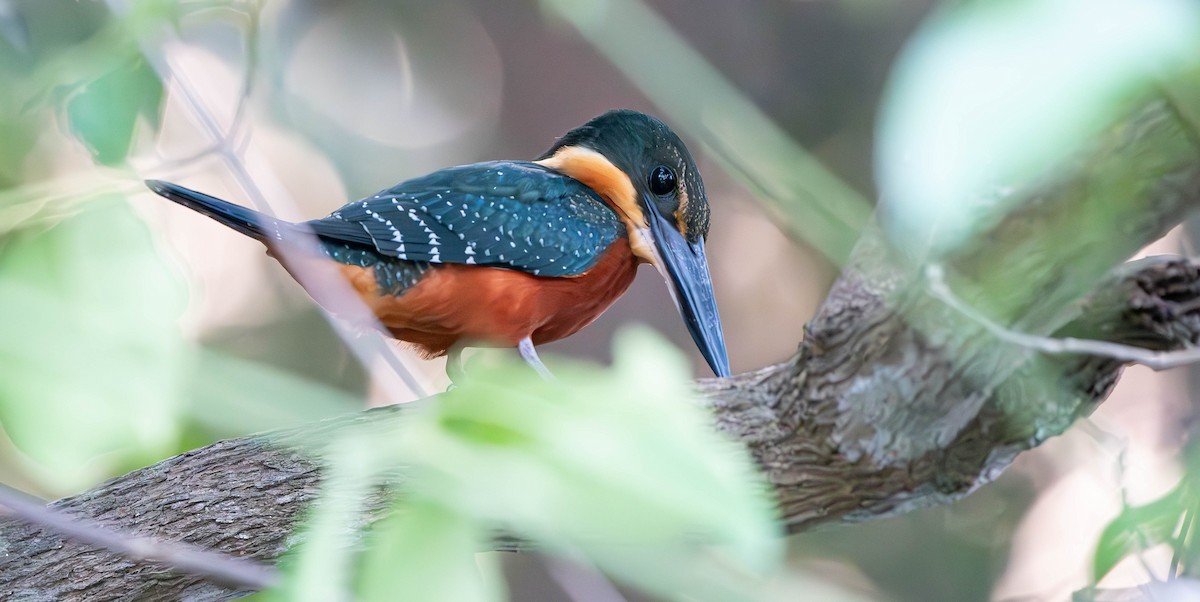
left=260, top=0, right=505, bottom=188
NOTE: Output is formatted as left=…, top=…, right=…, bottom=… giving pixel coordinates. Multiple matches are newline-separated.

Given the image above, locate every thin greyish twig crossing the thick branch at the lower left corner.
left=0, top=484, right=280, bottom=590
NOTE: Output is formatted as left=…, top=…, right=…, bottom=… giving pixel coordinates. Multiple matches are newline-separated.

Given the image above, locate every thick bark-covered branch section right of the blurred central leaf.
left=731, top=97, right=1200, bottom=529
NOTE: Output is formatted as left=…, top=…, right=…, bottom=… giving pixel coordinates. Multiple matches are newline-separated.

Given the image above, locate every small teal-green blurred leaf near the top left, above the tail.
left=66, top=54, right=163, bottom=165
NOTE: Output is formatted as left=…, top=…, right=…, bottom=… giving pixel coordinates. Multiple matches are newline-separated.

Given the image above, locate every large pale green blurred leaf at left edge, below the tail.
left=0, top=197, right=187, bottom=490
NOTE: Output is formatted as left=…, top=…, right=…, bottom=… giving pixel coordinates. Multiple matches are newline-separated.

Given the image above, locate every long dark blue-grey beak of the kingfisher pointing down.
left=646, top=199, right=730, bottom=377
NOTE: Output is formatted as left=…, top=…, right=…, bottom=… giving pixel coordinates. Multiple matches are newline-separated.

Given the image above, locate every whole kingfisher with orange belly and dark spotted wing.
left=146, top=109, right=730, bottom=378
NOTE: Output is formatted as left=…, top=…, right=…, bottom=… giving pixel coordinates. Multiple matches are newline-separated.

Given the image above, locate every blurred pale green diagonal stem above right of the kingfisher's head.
left=541, top=0, right=870, bottom=263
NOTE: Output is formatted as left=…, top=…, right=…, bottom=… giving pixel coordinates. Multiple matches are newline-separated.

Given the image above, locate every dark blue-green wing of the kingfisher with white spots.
left=308, top=161, right=624, bottom=276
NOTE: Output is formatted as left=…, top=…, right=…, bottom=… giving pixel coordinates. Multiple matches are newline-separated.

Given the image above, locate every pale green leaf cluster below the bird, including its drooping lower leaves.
left=268, top=331, right=782, bottom=600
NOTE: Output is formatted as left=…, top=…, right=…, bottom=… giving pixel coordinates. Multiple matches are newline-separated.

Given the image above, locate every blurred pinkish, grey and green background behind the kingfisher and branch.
left=0, top=0, right=1193, bottom=601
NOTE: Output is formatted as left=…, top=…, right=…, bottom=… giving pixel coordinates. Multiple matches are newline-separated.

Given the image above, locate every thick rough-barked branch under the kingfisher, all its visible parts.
left=0, top=100, right=1200, bottom=600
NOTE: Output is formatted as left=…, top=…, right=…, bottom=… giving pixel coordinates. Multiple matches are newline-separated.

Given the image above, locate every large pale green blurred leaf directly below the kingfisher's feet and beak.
left=395, top=331, right=782, bottom=598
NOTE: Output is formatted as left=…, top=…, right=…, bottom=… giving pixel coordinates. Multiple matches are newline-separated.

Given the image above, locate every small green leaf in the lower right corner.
left=1092, top=482, right=1187, bottom=583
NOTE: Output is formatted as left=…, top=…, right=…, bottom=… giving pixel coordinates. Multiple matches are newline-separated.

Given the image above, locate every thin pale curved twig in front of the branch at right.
left=925, top=264, right=1200, bottom=371
